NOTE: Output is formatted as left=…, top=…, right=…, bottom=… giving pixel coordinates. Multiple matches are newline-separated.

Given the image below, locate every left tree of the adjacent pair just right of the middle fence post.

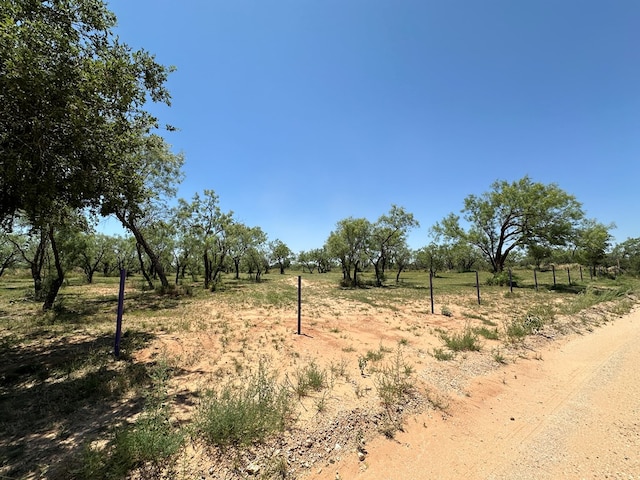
left=326, top=217, right=372, bottom=287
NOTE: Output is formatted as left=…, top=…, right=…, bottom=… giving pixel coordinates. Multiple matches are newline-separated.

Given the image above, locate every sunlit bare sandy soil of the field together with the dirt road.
left=127, top=280, right=640, bottom=480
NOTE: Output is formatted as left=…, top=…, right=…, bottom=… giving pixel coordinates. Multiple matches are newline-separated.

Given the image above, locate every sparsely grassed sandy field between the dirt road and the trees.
left=0, top=271, right=637, bottom=479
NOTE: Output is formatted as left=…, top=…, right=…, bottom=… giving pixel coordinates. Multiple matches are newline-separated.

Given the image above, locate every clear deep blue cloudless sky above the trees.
left=108, top=0, right=640, bottom=252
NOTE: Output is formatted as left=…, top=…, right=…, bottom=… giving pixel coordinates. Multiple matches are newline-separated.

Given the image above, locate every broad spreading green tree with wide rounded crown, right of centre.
left=433, top=176, right=584, bottom=272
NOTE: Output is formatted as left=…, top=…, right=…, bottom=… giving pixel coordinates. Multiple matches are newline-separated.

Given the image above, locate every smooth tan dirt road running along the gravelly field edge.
left=310, top=310, right=640, bottom=480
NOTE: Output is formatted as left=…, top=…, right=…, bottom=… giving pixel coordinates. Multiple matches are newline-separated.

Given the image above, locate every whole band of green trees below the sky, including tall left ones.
left=0, top=0, right=640, bottom=309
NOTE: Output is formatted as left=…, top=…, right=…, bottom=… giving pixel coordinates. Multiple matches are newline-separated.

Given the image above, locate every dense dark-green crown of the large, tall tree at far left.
left=0, top=0, right=171, bottom=225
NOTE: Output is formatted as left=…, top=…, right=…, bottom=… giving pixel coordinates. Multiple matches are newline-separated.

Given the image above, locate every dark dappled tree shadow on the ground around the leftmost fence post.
left=0, top=331, right=170, bottom=479
